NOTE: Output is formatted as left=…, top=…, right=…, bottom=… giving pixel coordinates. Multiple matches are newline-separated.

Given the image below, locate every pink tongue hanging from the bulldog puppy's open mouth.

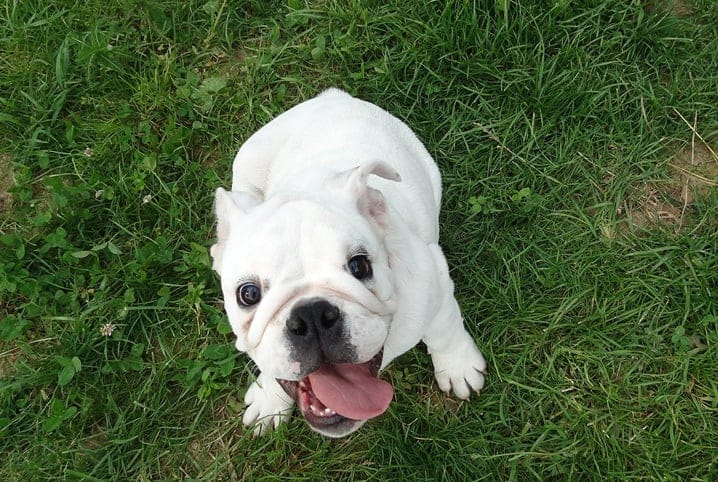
left=309, top=363, right=394, bottom=420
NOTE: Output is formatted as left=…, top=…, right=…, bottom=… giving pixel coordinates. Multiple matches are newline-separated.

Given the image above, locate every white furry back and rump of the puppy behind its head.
left=232, top=89, right=441, bottom=242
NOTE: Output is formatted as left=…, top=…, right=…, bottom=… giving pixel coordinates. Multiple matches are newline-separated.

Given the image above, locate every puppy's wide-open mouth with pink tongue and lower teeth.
left=277, top=351, right=394, bottom=435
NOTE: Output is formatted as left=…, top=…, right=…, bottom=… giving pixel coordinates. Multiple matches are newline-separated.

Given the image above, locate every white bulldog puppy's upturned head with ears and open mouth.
left=211, top=162, right=400, bottom=437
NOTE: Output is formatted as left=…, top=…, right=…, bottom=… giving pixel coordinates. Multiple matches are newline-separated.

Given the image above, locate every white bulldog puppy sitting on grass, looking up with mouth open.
left=211, top=89, right=486, bottom=437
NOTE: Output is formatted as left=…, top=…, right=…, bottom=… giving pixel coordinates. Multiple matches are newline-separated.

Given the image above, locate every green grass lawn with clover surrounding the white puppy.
left=0, top=0, right=718, bottom=481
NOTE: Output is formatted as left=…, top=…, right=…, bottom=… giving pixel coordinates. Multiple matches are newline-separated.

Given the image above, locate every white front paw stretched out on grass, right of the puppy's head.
left=431, top=342, right=486, bottom=400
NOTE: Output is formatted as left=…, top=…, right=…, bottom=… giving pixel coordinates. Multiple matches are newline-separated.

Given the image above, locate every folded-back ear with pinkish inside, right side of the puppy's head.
left=339, top=161, right=401, bottom=227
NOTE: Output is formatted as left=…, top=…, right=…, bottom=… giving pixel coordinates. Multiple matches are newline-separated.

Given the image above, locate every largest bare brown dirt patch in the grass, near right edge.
left=619, top=144, right=718, bottom=232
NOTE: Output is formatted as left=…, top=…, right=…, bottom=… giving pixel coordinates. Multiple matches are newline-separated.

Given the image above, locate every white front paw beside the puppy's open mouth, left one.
left=242, top=374, right=294, bottom=435
